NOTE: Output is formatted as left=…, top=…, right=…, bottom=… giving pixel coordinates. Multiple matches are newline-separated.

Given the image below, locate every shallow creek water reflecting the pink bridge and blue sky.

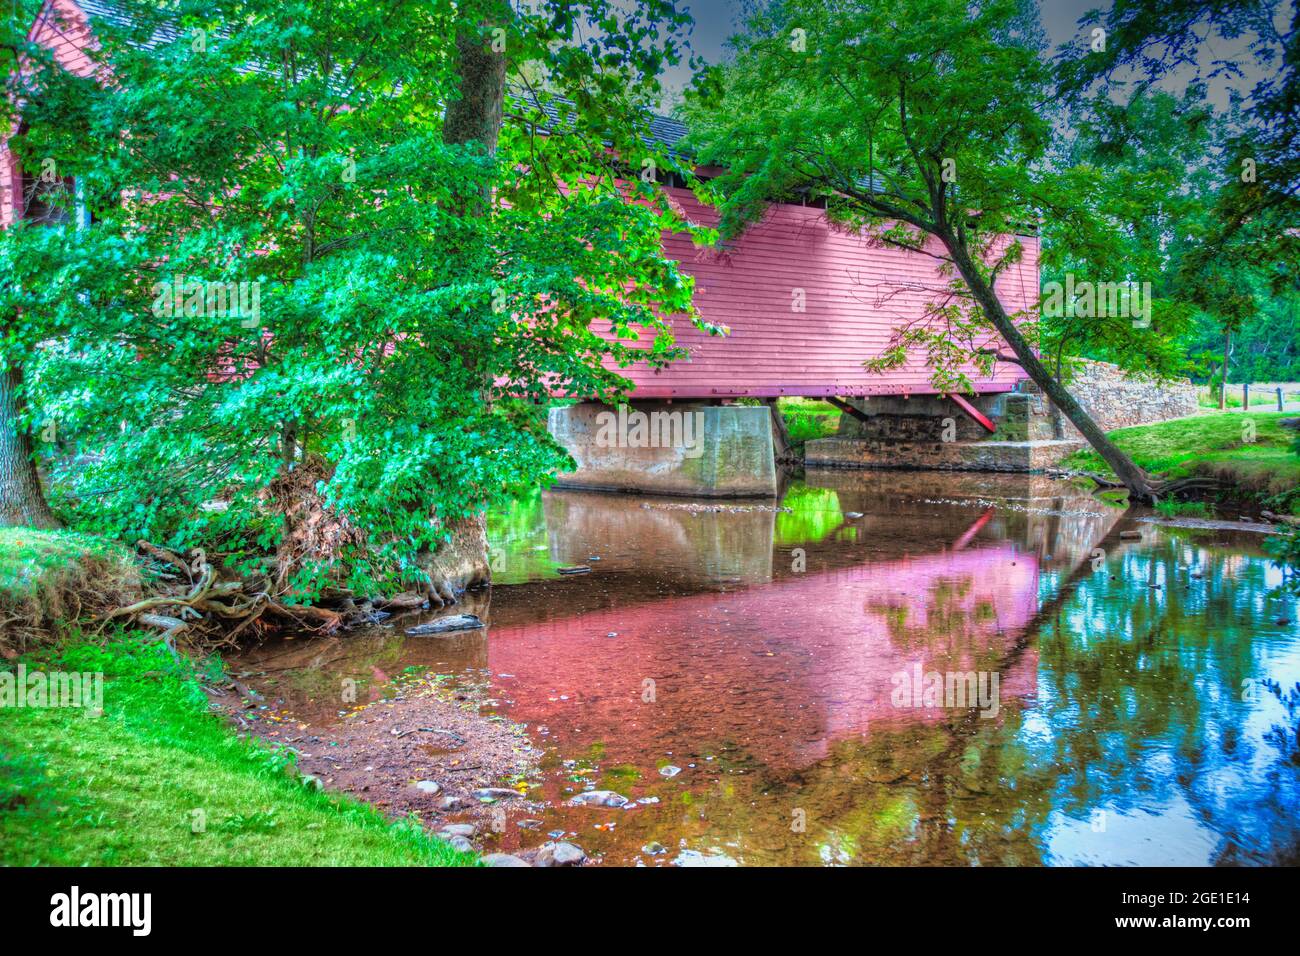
left=230, top=471, right=1300, bottom=866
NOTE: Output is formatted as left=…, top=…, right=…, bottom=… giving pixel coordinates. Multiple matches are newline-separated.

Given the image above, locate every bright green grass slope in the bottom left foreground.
left=0, top=636, right=475, bottom=866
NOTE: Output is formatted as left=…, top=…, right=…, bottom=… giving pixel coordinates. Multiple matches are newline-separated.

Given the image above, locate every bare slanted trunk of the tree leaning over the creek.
left=944, top=237, right=1156, bottom=501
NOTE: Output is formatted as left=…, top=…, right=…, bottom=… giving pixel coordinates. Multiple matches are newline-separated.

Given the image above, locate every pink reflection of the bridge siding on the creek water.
left=488, top=544, right=1039, bottom=769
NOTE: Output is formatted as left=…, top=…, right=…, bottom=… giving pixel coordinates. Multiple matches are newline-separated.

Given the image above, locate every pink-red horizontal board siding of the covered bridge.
left=603, top=189, right=1039, bottom=398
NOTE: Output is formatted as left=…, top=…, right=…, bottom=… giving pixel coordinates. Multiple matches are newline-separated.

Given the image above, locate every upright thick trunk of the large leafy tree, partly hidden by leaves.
left=410, top=12, right=508, bottom=606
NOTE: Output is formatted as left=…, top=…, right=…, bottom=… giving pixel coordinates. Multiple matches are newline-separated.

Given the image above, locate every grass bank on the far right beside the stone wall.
left=1062, top=412, right=1300, bottom=507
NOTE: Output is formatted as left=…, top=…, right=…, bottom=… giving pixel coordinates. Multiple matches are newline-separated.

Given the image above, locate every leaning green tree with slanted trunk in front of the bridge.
left=690, top=0, right=1157, bottom=499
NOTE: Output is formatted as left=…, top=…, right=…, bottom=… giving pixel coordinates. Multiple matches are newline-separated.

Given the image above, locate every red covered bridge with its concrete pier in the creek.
left=0, top=0, right=1039, bottom=494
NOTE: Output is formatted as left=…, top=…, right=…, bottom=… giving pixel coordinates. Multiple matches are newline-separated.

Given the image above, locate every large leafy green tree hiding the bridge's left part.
left=10, top=0, right=693, bottom=602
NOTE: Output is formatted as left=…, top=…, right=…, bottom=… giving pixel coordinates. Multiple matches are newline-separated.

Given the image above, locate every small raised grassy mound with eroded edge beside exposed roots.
left=0, top=528, right=139, bottom=656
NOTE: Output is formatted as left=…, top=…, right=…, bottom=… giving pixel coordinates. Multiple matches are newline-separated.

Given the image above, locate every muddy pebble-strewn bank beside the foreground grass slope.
left=213, top=596, right=577, bottom=864
